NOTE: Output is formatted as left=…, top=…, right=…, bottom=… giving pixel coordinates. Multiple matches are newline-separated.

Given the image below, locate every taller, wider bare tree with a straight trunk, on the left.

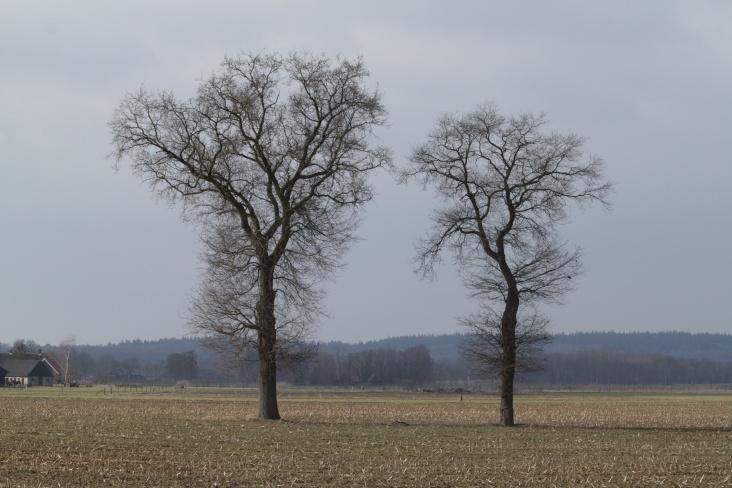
left=109, top=50, right=391, bottom=419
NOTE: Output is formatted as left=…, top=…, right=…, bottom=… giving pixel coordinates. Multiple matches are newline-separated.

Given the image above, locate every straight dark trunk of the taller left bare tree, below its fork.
left=257, top=259, right=280, bottom=420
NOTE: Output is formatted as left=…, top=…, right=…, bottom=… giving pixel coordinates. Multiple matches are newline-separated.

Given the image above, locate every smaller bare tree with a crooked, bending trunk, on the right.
left=402, top=103, right=612, bottom=426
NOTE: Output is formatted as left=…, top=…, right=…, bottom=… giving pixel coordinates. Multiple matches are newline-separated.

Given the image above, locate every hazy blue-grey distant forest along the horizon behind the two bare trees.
left=0, top=332, right=732, bottom=387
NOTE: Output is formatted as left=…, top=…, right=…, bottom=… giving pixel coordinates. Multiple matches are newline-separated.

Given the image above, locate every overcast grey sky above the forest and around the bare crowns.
left=0, top=0, right=732, bottom=344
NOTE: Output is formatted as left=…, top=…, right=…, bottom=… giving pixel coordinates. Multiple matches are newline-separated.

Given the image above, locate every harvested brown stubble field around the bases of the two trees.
left=0, top=388, right=732, bottom=488
